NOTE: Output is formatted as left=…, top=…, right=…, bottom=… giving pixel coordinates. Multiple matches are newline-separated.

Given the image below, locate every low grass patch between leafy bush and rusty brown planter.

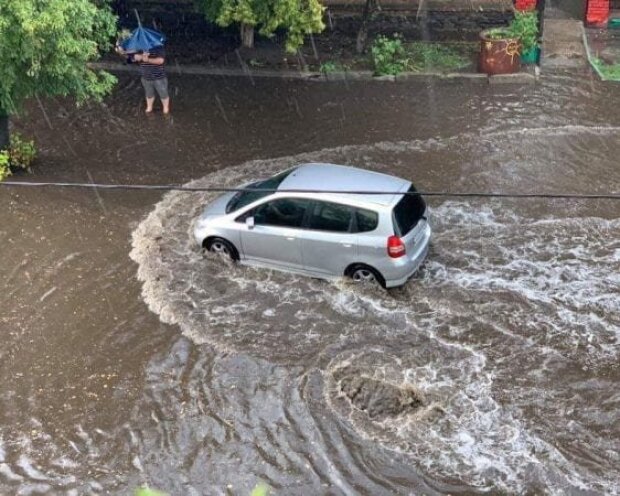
left=406, top=41, right=473, bottom=72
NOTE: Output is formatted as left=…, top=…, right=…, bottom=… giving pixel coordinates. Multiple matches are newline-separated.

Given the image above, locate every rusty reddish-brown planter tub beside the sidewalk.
left=478, top=28, right=521, bottom=75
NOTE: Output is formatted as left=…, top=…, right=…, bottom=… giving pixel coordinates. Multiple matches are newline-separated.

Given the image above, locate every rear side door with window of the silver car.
left=300, top=201, right=357, bottom=276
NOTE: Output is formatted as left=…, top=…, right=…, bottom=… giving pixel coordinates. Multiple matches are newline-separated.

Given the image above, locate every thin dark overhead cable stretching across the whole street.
left=0, top=181, right=620, bottom=200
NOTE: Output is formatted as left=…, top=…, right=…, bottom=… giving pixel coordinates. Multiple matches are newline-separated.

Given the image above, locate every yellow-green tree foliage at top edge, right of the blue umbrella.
left=196, top=0, right=325, bottom=52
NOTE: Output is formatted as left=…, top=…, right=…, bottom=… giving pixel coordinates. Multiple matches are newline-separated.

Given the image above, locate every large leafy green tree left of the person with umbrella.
left=0, top=0, right=116, bottom=150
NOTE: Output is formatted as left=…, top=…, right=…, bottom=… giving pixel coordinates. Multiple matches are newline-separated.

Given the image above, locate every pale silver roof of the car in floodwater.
left=278, top=163, right=411, bottom=206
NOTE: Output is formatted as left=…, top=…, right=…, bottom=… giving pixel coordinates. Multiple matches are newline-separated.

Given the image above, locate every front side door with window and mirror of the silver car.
left=238, top=198, right=309, bottom=269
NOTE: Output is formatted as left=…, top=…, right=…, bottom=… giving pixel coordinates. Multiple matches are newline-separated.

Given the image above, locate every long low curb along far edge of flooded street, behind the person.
left=89, top=62, right=537, bottom=84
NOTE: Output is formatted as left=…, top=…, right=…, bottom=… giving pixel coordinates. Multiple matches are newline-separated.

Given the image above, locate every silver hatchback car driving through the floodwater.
left=194, top=163, right=431, bottom=288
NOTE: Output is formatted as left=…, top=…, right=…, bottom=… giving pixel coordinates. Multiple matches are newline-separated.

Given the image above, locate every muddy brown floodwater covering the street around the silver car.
left=0, top=74, right=620, bottom=495
